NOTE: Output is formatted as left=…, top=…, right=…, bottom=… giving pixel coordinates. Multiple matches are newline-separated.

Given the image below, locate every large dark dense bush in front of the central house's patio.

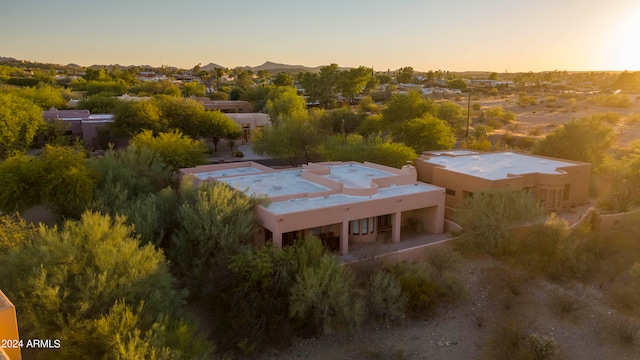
left=211, top=238, right=363, bottom=353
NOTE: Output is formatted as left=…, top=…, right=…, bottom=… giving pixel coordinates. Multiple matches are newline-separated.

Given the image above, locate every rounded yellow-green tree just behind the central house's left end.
left=131, top=130, right=209, bottom=171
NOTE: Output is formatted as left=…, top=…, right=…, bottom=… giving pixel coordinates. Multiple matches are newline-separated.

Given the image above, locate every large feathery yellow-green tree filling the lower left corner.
left=0, top=212, right=211, bottom=359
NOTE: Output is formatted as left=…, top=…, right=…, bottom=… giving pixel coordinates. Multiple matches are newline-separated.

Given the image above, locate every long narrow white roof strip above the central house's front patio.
left=264, top=184, right=442, bottom=215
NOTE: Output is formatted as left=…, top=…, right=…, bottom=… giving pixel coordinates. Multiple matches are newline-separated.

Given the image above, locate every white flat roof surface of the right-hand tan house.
left=421, top=152, right=577, bottom=180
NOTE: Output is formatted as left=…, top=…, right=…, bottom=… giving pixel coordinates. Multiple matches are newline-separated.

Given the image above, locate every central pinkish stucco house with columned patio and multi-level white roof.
left=180, top=162, right=445, bottom=255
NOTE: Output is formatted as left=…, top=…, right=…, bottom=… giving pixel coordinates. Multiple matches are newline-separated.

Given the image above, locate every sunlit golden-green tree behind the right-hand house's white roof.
left=532, top=117, right=615, bottom=169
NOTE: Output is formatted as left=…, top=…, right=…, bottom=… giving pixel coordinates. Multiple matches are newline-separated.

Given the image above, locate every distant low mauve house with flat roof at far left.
left=42, top=107, right=114, bottom=149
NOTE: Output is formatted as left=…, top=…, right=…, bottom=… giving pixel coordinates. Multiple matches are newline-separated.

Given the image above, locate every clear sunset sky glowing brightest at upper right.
left=0, top=0, right=640, bottom=72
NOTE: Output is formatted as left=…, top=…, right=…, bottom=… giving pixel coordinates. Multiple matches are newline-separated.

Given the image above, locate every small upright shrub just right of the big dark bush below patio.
left=366, top=271, right=407, bottom=323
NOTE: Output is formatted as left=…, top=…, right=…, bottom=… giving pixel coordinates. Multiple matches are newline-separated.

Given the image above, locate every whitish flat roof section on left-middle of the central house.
left=220, top=168, right=330, bottom=198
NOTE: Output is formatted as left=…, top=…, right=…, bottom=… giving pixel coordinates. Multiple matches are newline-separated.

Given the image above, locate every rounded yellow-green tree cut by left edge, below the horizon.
left=0, top=93, right=44, bottom=159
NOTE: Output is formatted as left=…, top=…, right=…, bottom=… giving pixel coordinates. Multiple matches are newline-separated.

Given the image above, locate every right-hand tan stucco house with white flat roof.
left=415, top=150, right=591, bottom=219
